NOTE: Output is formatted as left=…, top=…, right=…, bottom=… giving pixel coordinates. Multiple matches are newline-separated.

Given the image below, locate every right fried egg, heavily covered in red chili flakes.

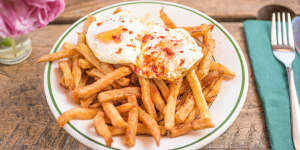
left=136, top=25, right=202, bottom=80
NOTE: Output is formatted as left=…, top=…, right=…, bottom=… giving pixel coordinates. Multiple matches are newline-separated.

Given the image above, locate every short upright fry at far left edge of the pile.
left=58, top=61, right=74, bottom=89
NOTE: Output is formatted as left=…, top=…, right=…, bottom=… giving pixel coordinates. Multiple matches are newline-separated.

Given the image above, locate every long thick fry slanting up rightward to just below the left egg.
left=73, top=67, right=131, bottom=98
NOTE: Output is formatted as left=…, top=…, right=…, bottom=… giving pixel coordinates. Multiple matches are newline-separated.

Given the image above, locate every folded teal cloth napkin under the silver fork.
left=244, top=20, right=300, bottom=150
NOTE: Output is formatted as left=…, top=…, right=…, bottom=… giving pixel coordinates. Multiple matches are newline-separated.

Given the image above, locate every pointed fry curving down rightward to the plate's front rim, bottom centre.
left=138, top=107, right=160, bottom=146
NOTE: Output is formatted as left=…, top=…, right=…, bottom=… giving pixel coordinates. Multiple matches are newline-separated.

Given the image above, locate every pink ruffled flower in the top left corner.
left=0, top=0, right=65, bottom=38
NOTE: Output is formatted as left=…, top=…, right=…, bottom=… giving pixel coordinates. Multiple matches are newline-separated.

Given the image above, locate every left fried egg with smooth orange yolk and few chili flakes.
left=86, top=11, right=144, bottom=64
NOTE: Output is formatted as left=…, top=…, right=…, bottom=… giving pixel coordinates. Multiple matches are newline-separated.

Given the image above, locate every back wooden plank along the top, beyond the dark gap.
left=56, top=0, right=300, bottom=22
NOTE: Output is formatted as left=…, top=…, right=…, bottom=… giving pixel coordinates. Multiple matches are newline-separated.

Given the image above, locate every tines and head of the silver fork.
left=271, top=12, right=294, bottom=49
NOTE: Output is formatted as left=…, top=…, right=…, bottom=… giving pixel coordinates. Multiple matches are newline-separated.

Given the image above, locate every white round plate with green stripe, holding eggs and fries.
left=44, top=1, right=248, bottom=150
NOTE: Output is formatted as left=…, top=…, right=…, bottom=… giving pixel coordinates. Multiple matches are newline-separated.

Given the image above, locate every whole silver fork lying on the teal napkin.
left=271, top=12, right=300, bottom=150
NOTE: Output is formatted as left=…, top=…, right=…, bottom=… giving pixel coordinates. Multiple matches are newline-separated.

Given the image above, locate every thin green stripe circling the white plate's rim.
left=47, top=1, right=245, bottom=150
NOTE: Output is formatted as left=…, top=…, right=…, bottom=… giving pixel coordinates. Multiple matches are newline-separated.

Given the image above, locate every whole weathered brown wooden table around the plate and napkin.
left=0, top=0, right=300, bottom=149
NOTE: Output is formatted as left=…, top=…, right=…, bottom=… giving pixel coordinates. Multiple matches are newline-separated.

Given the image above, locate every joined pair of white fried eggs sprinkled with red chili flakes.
left=86, top=11, right=202, bottom=80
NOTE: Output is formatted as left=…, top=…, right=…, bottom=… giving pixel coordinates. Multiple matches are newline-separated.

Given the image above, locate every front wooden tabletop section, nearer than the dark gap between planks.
left=0, top=23, right=269, bottom=149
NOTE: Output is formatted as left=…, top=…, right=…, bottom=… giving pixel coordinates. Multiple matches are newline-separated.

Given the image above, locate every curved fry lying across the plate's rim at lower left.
left=57, top=108, right=98, bottom=128
